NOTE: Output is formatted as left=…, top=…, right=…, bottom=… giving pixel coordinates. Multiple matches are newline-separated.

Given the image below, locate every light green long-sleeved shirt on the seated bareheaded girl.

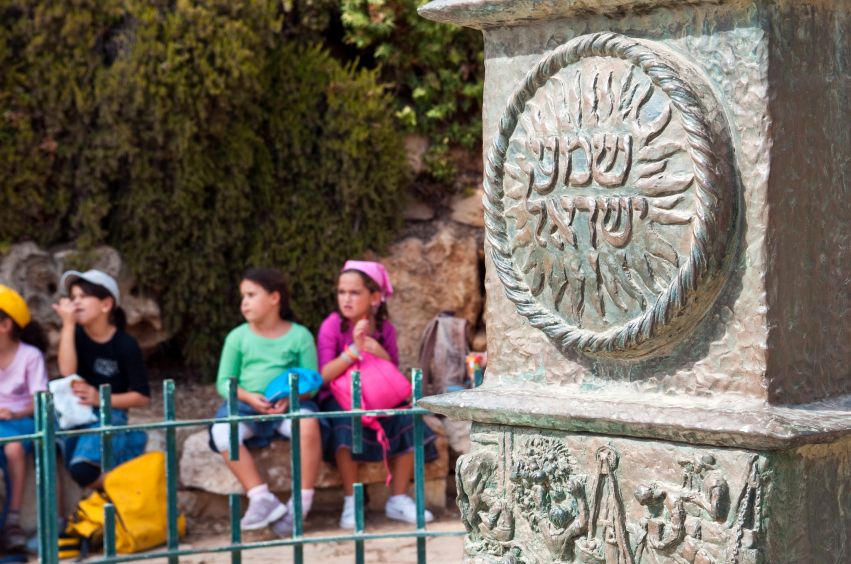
left=216, top=323, right=318, bottom=398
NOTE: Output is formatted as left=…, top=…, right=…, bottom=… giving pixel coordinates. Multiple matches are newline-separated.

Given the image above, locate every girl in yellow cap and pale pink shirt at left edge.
left=0, top=284, right=47, bottom=551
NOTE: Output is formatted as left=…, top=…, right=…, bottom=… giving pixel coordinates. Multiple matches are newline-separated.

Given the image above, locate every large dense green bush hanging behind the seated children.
left=0, top=0, right=406, bottom=370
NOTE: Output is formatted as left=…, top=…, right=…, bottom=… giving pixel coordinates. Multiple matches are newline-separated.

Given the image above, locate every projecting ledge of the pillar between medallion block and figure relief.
left=421, top=385, right=851, bottom=450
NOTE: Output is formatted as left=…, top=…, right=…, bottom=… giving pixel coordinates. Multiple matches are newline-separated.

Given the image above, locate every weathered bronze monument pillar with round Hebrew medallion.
left=420, top=0, right=851, bottom=564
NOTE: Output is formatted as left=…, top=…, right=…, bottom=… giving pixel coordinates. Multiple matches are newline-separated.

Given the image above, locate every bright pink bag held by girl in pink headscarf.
left=330, top=352, right=411, bottom=485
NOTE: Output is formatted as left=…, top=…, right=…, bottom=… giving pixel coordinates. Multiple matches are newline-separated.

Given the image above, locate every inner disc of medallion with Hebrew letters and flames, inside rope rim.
left=504, top=57, right=695, bottom=330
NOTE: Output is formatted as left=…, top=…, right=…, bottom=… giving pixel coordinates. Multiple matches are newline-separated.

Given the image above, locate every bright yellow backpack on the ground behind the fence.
left=59, top=451, right=186, bottom=558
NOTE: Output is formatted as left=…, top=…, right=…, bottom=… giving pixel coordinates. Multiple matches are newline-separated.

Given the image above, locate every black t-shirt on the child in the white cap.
left=74, top=325, right=151, bottom=397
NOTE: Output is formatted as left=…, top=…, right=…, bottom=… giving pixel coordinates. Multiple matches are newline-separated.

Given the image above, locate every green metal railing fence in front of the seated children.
left=0, top=367, right=482, bottom=564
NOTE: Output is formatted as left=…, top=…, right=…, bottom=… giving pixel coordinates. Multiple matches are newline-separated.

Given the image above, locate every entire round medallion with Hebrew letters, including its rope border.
left=485, top=33, right=736, bottom=356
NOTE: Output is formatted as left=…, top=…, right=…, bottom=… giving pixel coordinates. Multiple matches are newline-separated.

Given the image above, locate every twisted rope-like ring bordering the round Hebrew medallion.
left=483, top=33, right=731, bottom=353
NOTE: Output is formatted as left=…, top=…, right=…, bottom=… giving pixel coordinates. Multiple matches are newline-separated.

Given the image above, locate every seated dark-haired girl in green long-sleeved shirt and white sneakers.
left=210, top=268, right=322, bottom=536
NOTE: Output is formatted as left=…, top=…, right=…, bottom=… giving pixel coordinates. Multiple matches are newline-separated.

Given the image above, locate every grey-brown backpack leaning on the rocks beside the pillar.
left=419, top=312, right=470, bottom=396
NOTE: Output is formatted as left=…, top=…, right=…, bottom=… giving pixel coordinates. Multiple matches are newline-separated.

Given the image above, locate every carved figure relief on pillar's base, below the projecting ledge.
left=456, top=431, right=770, bottom=564
